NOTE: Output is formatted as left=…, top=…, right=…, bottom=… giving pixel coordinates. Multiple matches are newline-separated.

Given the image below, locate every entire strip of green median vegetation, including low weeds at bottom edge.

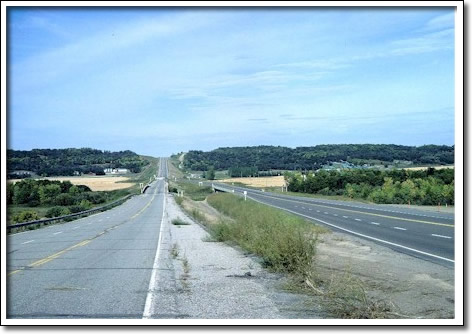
left=171, top=180, right=404, bottom=319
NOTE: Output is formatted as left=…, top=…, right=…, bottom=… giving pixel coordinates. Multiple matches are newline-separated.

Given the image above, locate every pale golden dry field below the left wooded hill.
left=8, top=176, right=134, bottom=191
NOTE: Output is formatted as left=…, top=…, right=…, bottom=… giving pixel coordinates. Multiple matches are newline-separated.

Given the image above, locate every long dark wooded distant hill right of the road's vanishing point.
left=180, top=144, right=454, bottom=171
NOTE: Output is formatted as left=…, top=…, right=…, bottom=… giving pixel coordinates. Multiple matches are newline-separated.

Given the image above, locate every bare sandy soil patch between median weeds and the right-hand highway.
left=316, top=232, right=454, bottom=319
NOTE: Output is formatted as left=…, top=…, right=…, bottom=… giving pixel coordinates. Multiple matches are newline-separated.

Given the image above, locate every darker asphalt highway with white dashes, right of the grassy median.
left=214, top=183, right=454, bottom=267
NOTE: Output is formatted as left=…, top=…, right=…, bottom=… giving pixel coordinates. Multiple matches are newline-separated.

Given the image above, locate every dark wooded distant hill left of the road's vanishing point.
left=7, top=148, right=149, bottom=176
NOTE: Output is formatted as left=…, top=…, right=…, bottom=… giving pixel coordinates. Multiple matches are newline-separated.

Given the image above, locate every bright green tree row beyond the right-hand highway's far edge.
left=285, top=168, right=454, bottom=205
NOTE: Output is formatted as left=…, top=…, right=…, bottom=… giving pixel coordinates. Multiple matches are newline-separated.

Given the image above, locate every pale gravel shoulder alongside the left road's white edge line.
left=152, top=195, right=321, bottom=319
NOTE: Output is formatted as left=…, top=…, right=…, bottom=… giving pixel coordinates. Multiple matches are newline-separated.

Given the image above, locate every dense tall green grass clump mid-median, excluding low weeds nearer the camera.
left=207, top=194, right=317, bottom=277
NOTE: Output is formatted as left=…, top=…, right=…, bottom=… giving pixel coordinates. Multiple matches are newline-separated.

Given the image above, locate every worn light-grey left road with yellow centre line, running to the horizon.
left=7, top=159, right=167, bottom=319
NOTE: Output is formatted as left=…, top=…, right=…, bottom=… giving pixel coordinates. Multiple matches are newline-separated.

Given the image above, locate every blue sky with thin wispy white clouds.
left=7, top=7, right=454, bottom=156
